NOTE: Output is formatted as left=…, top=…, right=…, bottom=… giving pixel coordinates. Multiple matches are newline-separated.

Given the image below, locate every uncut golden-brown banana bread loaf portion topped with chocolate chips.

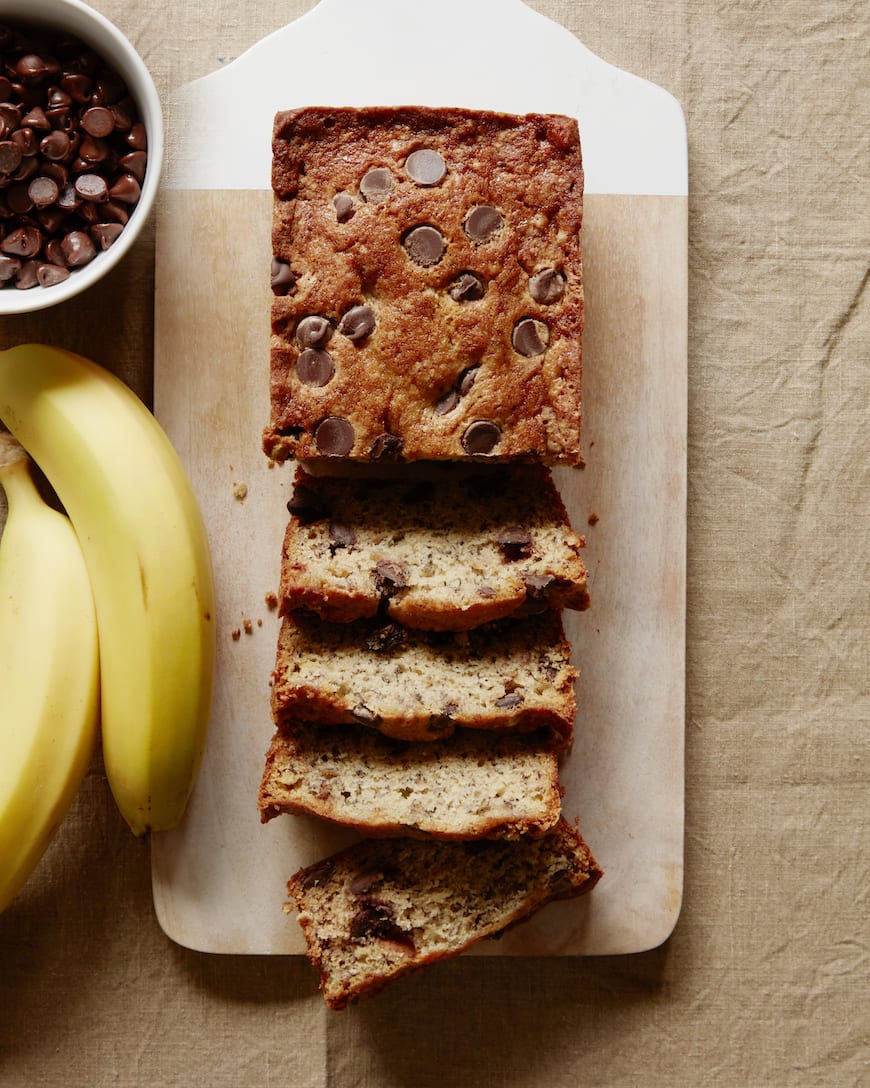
left=263, top=107, right=583, bottom=463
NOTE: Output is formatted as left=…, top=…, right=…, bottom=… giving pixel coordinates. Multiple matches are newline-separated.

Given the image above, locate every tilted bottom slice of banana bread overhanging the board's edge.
left=285, top=820, right=602, bottom=1009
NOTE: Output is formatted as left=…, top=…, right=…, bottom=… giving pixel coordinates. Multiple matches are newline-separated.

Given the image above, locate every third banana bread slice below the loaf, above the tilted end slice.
left=259, top=721, right=561, bottom=839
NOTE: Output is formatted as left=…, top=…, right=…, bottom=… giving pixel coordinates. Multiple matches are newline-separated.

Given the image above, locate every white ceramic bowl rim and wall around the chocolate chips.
left=0, top=0, right=163, bottom=316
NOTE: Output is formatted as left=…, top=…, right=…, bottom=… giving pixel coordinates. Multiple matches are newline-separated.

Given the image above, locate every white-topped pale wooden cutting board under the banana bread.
left=152, top=0, right=687, bottom=955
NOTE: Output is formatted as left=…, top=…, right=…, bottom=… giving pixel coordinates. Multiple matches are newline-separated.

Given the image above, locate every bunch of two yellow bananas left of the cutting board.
left=0, top=344, right=215, bottom=911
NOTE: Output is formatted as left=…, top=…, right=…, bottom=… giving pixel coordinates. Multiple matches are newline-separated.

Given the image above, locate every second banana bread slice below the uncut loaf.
left=272, top=611, right=577, bottom=746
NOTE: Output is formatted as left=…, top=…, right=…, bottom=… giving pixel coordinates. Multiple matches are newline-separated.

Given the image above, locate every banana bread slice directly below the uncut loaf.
left=279, top=465, right=589, bottom=631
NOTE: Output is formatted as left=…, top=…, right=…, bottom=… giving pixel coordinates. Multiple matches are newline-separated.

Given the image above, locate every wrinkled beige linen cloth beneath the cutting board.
left=0, top=0, right=870, bottom=1088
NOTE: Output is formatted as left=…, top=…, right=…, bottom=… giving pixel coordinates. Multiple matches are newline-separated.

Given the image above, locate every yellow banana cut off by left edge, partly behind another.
left=0, top=433, right=99, bottom=911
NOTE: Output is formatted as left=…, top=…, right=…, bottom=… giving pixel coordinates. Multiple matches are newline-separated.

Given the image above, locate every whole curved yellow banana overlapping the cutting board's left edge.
left=0, top=344, right=215, bottom=834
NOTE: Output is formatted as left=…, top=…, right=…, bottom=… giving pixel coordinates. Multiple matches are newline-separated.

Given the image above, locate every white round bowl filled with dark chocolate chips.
left=0, top=0, right=163, bottom=314
